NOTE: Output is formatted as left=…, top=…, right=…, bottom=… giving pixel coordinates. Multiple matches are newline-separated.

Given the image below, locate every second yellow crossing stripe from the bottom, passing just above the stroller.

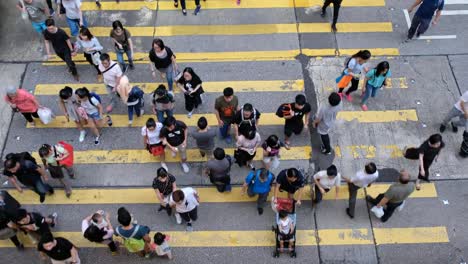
left=9, top=184, right=437, bottom=204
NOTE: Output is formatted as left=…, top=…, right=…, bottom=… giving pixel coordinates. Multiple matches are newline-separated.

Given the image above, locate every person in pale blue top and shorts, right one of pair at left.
left=75, top=87, right=105, bottom=145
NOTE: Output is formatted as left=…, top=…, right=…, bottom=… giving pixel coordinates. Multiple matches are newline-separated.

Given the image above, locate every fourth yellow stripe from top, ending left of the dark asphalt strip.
left=34, top=80, right=304, bottom=95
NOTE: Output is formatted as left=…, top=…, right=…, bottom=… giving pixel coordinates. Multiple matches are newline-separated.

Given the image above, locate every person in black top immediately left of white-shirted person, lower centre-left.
left=153, top=168, right=177, bottom=216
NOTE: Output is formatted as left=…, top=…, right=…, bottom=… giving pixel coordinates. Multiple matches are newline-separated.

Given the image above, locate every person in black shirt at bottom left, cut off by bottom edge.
left=37, top=233, right=81, bottom=264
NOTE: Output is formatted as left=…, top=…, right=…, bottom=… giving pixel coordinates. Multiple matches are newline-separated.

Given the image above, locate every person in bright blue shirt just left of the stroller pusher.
left=242, top=168, right=275, bottom=215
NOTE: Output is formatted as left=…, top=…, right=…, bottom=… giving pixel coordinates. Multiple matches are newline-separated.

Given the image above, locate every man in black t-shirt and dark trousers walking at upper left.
left=43, top=18, right=80, bottom=81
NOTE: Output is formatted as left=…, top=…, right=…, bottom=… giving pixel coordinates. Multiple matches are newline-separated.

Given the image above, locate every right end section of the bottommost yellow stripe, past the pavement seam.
left=374, top=226, right=449, bottom=245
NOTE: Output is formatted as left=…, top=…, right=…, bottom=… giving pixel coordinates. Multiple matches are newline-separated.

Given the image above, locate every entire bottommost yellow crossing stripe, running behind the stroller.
left=0, top=224, right=450, bottom=248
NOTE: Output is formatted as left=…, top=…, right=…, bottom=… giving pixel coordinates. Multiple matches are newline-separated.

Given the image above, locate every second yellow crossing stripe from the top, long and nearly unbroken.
left=64, top=22, right=393, bottom=37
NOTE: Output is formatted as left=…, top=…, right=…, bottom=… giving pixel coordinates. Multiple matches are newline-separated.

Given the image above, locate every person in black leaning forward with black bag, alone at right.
left=404, top=134, right=445, bottom=191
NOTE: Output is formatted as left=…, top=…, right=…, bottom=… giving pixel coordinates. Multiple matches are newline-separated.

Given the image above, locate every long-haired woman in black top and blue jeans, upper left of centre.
left=149, top=38, right=179, bottom=95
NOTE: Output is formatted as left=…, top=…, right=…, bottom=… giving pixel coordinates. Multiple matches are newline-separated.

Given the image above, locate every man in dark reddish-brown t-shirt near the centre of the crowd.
left=214, top=87, right=240, bottom=144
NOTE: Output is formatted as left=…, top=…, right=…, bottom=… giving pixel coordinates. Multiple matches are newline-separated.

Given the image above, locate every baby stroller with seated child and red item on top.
left=271, top=198, right=296, bottom=258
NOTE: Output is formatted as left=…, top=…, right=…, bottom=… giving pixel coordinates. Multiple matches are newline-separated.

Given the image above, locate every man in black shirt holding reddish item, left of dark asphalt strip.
left=276, top=94, right=312, bottom=146
